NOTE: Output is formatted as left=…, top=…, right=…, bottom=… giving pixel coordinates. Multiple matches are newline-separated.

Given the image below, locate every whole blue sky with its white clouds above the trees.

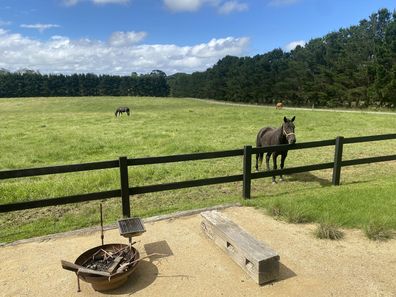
left=0, top=0, right=396, bottom=75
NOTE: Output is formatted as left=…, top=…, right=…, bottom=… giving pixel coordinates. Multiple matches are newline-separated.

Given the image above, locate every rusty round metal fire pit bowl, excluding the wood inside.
left=74, top=243, right=139, bottom=291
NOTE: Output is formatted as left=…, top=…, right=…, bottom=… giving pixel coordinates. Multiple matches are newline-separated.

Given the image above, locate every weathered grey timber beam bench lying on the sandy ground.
left=201, top=210, right=280, bottom=285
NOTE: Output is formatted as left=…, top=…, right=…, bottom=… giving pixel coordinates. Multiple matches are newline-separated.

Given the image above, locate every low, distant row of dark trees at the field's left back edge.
left=0, top=70, right=169, bottom=97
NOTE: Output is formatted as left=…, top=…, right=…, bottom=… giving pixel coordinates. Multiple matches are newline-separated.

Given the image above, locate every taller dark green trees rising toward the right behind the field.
left=168, top=9, right=396, bottom=107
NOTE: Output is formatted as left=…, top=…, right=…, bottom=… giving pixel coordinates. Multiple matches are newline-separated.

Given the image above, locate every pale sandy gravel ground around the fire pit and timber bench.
left=0, top=207, right=396, bottom=297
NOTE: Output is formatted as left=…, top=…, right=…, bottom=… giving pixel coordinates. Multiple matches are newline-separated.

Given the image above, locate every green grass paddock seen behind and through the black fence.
left=0, top=97, right=396, bottom=242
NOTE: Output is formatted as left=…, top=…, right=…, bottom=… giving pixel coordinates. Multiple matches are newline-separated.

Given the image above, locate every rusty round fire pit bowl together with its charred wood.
left=69, top=243, right=139, bottom=291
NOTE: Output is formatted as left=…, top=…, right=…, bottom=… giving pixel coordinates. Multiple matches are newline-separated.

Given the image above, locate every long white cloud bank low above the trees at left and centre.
left=0, top=29, right=249, bottom=75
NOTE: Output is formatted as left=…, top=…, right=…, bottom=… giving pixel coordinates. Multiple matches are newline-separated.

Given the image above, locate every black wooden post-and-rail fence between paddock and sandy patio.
left=0, top=134, right=396, bottom=217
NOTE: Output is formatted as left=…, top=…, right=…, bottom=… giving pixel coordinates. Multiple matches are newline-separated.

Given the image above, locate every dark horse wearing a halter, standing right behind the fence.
left=256, top=117, right=296, bottom=183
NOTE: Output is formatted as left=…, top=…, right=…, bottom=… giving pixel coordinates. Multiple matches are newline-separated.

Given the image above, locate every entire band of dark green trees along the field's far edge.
left=0, top=9, right=396, bottom=108
